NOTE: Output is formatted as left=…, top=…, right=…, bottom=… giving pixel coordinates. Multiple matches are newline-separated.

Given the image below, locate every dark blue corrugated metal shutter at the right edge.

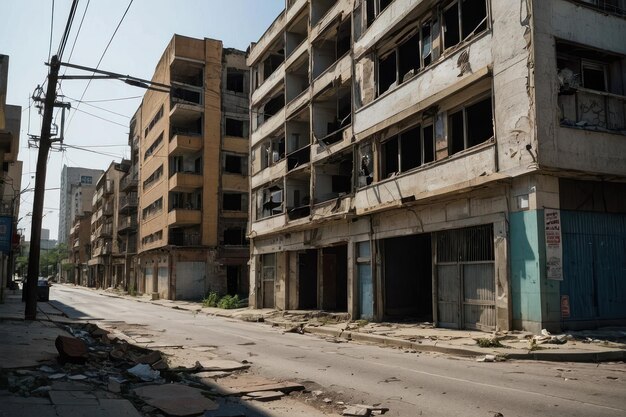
left=561, top=210, right=626, bottom=327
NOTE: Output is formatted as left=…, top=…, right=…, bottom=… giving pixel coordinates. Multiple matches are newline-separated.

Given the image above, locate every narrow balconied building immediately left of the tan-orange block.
left=116, top=108, right=141, bottom=294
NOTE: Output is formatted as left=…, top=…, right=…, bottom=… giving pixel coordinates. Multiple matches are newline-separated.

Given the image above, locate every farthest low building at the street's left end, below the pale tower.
left=70, top=211, right=91, bottom=286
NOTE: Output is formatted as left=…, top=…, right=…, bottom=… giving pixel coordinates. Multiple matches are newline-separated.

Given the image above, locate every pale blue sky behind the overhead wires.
left=0, top=0, right=285, bottom=240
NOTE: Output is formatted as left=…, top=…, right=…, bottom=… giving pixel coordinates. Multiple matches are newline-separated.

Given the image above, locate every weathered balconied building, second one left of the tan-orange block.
left=87, top=160, right=130, bottom=288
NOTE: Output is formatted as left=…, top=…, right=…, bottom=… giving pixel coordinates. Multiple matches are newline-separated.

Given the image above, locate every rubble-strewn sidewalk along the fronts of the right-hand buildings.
left=92, top=289, right=626, bottom=363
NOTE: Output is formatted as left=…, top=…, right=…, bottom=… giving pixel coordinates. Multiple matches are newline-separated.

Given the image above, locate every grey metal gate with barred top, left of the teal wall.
left=435, top=224, right=496, bottom=330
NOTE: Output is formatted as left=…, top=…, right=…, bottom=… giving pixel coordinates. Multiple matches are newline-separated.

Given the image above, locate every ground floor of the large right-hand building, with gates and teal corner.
left=250, top=175, right=626, bottom=331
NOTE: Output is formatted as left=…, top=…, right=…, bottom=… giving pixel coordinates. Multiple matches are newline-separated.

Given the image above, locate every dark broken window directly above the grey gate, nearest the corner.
left=448, top=96, right=493, bottom=155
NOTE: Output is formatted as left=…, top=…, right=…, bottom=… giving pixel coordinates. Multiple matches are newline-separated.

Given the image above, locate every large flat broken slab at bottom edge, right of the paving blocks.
left=134, top=384, right=218, bottom=416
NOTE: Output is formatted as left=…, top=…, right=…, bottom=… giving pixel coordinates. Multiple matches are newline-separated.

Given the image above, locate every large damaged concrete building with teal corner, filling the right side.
left=248, top=0, right=626, bottom=331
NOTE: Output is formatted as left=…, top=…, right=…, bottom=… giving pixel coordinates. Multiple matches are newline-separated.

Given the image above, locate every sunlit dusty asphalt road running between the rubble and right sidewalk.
left=50, top=285, right=626, bottom=417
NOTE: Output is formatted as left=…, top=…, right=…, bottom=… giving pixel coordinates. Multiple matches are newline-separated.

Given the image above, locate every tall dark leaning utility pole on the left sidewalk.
left=24, top=55, right=61, bottom=320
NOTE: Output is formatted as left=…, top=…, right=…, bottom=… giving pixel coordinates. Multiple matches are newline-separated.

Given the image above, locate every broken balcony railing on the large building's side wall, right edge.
left=559, top=88, right=626, bottom=132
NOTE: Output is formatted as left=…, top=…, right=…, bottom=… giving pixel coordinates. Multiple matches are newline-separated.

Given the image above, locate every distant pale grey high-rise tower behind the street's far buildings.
left=58, top=165, right=103, bottom=243
